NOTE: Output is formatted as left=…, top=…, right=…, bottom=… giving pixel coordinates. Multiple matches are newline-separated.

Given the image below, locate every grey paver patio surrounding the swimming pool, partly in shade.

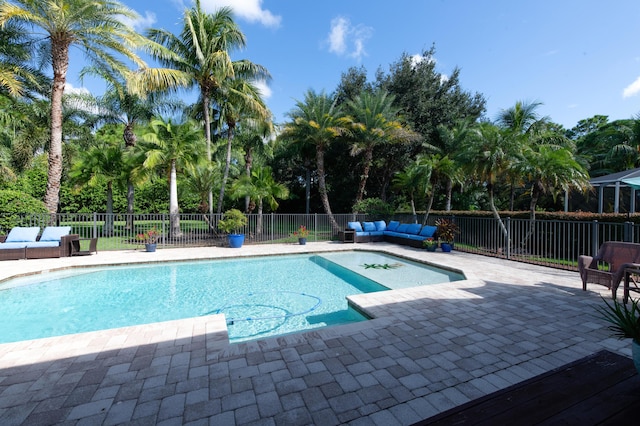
left=0, top=243, right=631, bottom=425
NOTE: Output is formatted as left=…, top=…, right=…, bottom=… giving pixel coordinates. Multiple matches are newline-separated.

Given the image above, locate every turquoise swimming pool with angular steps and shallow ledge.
left=0, top=252, right=463, bottom=343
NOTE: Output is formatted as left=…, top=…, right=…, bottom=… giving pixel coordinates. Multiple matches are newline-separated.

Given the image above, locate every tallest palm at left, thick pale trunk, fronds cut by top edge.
left=0, top=0, right=150, bottom=213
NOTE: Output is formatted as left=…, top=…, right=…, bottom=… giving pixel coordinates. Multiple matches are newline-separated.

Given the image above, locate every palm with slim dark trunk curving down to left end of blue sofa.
left=283, top=89, right=349, bottom=231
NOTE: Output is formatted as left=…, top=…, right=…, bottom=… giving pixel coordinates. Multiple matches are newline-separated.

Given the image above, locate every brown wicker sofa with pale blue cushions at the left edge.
left=0, top=226, right=78, bottom=260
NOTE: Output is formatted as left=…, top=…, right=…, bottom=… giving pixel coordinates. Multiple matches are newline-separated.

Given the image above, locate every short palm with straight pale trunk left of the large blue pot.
left=140, top=119, right=205, bottom=238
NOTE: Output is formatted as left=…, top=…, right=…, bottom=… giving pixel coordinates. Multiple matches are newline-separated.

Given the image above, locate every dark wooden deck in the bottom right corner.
left=414, top=351, right=640, bottom=426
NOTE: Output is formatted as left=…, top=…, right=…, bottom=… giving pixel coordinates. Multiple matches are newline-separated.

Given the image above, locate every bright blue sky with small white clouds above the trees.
left=68, top=0, right=640, bottom=128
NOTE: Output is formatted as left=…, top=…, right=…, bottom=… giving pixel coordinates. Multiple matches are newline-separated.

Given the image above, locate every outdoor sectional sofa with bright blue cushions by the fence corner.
left=347, top=220, right=438, bottom=248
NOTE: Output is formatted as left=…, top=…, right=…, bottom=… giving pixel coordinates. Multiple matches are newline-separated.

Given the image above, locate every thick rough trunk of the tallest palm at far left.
left=44, top=40, right=69, bottom=214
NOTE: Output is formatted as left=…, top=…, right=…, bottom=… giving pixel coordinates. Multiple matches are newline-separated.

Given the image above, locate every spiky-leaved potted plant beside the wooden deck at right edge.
left=596, top=298, right=640, bottom=373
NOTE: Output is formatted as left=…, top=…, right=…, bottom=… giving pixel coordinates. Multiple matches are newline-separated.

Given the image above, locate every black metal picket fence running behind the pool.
left=0, top=213, right=640, bottom=270
